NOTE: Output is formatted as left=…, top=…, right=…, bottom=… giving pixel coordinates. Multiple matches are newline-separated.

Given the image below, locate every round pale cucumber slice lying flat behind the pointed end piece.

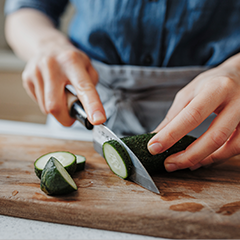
left=34, top=151, right=77, bottom=179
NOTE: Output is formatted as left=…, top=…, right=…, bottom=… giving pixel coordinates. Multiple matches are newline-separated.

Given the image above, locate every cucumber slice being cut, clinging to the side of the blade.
left=103, top=140, right=132, bottom=179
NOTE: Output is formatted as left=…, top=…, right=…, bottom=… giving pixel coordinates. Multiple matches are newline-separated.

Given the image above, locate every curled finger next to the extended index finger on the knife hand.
left=41, top=58, right=75, bottom=126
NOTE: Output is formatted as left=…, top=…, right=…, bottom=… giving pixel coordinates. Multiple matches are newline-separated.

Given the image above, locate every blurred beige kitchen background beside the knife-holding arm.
left=0, top=0, right=74, bottom=123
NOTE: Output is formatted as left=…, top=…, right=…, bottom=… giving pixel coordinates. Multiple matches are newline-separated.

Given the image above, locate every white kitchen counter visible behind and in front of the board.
left=0, top=120, right=162, bottom=240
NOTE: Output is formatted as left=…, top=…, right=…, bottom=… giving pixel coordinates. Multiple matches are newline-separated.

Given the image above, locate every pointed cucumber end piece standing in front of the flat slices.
left=40, top=157, right=77, bottom=195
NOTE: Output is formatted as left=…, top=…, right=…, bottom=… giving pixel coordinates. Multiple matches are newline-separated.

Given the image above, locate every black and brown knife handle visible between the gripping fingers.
left=65, top=87, right=93, bottom=130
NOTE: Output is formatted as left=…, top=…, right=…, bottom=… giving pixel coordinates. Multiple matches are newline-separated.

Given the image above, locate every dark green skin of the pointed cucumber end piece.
left=40, top=157, right=77, bottom=195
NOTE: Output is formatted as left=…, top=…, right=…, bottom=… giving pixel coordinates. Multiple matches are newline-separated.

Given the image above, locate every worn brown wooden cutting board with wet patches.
left=0, top=135, right=240, bottom=238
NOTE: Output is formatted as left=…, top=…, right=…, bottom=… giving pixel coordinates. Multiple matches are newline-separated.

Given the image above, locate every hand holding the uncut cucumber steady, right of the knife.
left=148, top=54, right=240, bottom=172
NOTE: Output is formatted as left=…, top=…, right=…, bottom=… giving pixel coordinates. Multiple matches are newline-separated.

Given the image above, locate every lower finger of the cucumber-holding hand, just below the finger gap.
left=164, top=102, right=239, bottom=171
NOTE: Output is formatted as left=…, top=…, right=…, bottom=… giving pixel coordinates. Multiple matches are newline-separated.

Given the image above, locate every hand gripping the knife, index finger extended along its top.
left=22, top=42, right=106, bottom=126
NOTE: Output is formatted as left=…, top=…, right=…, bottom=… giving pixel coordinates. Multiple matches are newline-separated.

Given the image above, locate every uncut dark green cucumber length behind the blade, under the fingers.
left=121, top=133, right=196, bottom=173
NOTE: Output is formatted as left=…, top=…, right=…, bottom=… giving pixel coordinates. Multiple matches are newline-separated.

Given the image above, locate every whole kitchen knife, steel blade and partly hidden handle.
left=66, top=85, right=160, bottom=194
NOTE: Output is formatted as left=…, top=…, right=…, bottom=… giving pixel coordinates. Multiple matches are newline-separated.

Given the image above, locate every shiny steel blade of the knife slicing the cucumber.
left=93, top=124, right=160, bottom=194
